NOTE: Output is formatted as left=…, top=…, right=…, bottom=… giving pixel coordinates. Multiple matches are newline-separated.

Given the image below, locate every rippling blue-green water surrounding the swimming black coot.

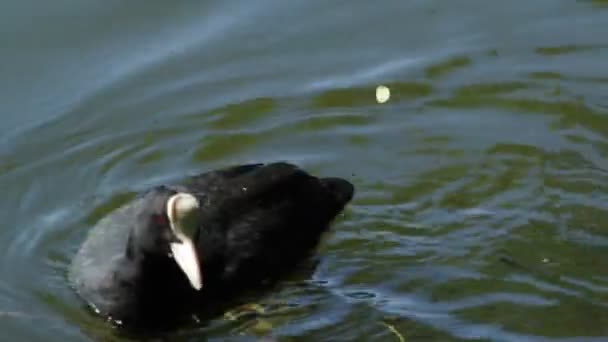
left=0, top=0, right=608, bottom=341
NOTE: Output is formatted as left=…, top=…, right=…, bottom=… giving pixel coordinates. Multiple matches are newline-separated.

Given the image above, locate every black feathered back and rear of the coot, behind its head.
left=182, top=163, right=354, bottom=292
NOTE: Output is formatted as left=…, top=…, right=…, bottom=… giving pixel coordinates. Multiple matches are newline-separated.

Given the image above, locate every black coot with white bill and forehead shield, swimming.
left=69, top=162, right=354, bottom=326
